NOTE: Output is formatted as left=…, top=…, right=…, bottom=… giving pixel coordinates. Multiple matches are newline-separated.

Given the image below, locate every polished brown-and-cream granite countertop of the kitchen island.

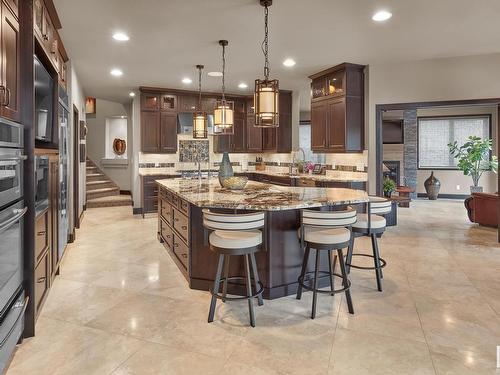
left=156, top=178, right=368, bottom=211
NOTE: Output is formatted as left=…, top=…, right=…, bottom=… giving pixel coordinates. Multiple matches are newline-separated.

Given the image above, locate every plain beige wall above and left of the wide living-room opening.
left=366, top=53, right=500, bottom=193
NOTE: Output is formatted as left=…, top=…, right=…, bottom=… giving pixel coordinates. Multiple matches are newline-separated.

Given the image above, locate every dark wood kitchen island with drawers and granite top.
left=156, top=178, right=368, bottom=299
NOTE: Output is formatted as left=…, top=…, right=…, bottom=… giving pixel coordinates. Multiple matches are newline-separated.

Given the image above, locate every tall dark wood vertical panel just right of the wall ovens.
left=19, top=1, right=36, bottom=337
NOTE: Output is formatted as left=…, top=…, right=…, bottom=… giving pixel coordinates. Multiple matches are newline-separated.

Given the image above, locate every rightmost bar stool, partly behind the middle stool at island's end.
left=346, top=196, right=392, bottom=292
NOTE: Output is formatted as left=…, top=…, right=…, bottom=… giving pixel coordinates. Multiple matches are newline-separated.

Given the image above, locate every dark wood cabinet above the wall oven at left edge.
left=0, top=2, right=21, bottom=122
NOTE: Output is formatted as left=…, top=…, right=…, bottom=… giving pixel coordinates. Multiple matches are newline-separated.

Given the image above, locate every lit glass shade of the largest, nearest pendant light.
left=254, top=79, right=279, bottom=128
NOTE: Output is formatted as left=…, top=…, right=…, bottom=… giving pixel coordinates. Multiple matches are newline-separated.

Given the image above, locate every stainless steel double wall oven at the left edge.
left=0, top=118, right=28, bottom=372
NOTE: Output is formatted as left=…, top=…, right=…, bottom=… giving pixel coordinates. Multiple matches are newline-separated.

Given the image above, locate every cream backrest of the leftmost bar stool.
left=203, top=210, right=264, bottom=230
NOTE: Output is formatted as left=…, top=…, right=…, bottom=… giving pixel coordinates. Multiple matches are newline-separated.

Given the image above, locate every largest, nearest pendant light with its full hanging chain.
left=254, top=0, right=279, bottom=128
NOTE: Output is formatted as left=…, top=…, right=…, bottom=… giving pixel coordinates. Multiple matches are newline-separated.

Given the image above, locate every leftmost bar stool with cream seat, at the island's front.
left=203, top=210, right=264, bottom=327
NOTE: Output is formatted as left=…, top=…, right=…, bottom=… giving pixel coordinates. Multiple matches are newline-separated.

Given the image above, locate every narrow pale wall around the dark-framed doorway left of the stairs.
left=67, top=61, right=86, bottom=228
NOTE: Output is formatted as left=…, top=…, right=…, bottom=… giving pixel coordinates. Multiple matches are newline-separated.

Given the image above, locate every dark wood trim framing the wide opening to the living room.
left=375, top=98, right=500, bottom=243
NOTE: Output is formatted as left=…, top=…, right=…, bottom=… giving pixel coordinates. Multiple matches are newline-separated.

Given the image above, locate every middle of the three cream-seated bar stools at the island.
left=297, top=207, right=356, bottom=319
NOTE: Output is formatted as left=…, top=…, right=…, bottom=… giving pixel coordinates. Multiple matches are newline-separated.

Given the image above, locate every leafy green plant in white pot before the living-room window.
left=448, top=136, right=498, bottom=193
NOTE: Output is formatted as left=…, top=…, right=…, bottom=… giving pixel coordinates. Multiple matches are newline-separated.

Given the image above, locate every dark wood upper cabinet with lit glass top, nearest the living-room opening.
left=309, top=63, right=365, bottom=152
